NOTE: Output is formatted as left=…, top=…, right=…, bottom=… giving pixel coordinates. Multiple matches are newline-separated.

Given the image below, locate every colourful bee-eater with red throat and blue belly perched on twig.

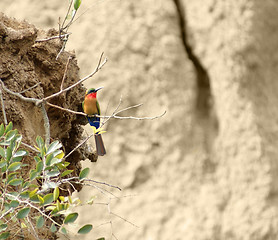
left=82, top=87, right=106, bottom=156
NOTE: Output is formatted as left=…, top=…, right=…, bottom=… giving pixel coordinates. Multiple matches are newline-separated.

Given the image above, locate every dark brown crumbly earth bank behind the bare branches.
left=0, top=14, right=93, bottom=188
